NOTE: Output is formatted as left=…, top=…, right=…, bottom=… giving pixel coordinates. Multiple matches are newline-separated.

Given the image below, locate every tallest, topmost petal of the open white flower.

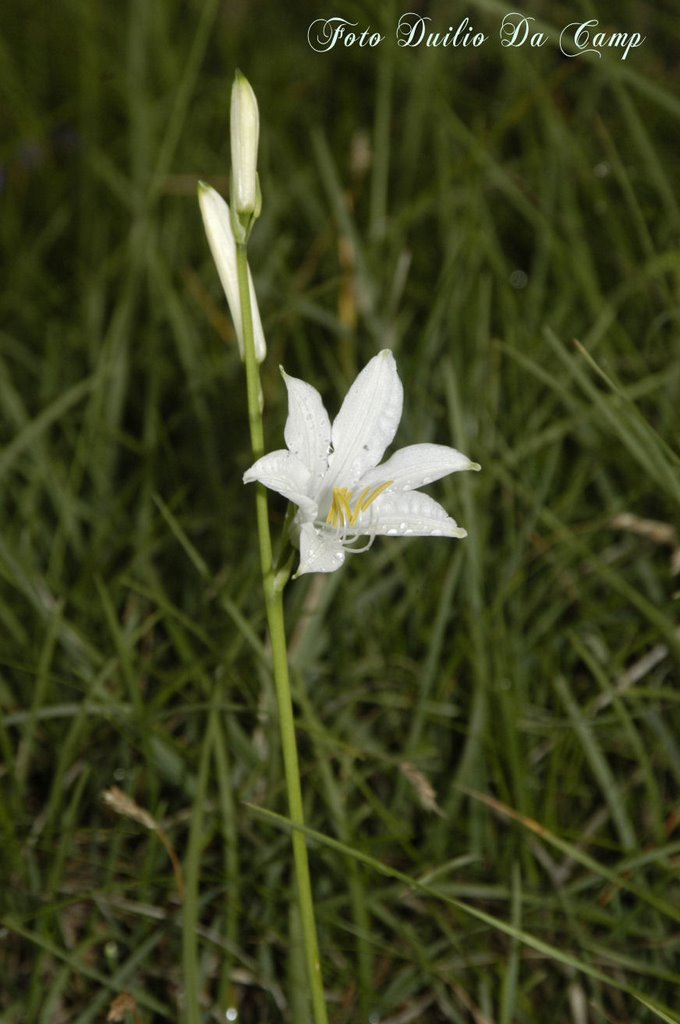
left=326, top=348, right=403, bottom=488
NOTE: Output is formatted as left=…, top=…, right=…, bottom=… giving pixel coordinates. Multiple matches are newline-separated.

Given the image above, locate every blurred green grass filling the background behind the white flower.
left=0, top=0, right=680, bottom=1024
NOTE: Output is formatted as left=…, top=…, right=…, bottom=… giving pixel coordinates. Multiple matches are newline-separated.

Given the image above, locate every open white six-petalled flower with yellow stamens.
left=244, top=349, right=479, bottom=575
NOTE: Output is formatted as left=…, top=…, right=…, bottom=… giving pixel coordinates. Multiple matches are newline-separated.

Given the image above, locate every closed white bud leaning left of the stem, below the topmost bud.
left=199, top=181, right=267, bottom=362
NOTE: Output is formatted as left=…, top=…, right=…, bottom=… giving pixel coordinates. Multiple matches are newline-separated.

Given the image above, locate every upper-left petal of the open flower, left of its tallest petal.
left=281, top=369, right=331, bottom=494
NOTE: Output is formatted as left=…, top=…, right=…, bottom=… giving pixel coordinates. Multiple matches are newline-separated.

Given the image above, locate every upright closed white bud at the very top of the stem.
left=229, top=71, right=260, bottom=220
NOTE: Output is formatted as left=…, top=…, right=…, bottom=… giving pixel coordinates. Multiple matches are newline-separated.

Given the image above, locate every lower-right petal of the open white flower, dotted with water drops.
left=356, top=490, right=467, bottom=538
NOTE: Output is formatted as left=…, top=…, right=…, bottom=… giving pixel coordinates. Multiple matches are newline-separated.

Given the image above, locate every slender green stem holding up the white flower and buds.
left=237, top=244, right=328, bottom=1024
